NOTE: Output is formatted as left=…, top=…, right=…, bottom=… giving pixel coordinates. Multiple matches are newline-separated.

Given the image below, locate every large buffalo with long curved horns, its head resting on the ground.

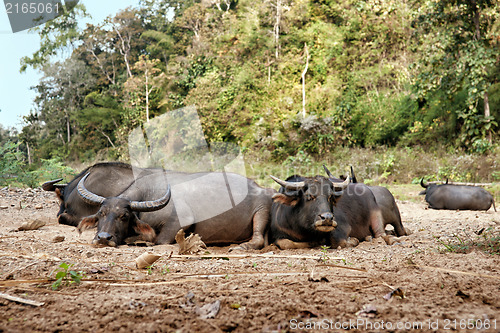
left=77, top=171, right=274, bottom=249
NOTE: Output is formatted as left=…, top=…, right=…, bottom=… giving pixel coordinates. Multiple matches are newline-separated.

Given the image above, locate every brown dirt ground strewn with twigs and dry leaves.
left=0, top=186, right=500, bottom=332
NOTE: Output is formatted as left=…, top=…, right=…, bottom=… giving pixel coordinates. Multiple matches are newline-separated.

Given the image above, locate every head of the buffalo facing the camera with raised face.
left=271, top=170, right=350, bottom=232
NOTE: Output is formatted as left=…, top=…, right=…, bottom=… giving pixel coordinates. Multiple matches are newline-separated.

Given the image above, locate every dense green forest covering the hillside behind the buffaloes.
left=0, top=0, right=500, bottom=184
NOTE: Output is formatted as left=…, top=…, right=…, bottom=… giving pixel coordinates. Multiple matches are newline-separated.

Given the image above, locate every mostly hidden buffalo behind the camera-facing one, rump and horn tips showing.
left=336, top=166, right=407, bottom=237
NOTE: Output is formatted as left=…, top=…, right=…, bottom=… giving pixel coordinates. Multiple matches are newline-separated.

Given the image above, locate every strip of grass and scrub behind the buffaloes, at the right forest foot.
left=245, top=146, right=500, bottom=188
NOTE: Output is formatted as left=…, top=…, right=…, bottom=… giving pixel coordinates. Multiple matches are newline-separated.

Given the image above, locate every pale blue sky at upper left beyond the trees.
left=0, top=0, right=139, bottom=130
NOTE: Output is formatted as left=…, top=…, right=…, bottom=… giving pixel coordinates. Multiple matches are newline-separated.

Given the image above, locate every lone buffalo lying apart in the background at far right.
left=420, top=178, right=497, bottom=212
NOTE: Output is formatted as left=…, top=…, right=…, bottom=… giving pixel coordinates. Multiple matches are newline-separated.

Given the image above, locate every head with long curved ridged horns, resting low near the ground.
left=78, top=174, right=170, bottom=246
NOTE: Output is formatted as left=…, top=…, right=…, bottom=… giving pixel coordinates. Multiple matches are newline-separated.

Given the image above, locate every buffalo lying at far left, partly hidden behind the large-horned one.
left=42, top=162, right=163, bottom=227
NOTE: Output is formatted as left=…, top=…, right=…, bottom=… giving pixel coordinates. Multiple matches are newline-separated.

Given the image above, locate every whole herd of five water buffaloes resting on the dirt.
left=42, top=162, right=496, bottom=249
